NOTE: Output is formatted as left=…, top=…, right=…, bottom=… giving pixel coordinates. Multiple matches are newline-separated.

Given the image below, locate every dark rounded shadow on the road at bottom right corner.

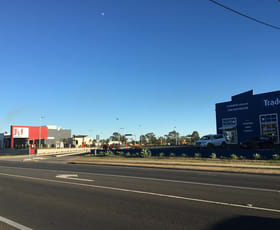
left=210, top=216, right=280, bottom=230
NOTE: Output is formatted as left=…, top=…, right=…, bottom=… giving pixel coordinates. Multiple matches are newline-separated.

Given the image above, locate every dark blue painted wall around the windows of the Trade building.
left=216, top=91, right=280, bottom=143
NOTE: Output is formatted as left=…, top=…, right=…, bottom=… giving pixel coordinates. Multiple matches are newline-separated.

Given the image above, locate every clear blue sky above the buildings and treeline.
left=0, top=0, right=280, bottom=137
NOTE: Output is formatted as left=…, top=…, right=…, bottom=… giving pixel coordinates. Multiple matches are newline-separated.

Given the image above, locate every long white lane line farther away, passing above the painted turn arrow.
left=0, top=166, right=280, bottom=193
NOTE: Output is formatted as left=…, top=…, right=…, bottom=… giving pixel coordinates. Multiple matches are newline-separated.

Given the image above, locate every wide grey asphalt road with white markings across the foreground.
left=0, top=158, right=280, bottom=230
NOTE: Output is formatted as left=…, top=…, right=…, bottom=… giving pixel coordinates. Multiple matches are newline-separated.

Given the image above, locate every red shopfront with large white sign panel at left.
left=10, top=125, right=48, bottom=148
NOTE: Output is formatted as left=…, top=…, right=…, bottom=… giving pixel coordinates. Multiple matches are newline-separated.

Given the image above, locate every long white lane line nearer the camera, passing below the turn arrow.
left=0, top=173, right=280, bottom=213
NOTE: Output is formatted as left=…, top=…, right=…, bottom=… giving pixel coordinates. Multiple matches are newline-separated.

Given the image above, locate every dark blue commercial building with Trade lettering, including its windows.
left=216, top=90, right=280, bottom=144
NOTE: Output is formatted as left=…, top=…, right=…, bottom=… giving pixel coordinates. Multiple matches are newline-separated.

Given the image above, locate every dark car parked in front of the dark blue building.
left=240, top=136, right=274, bottom=149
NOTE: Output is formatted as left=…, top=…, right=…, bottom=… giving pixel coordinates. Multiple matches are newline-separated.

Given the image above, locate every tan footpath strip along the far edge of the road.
left=68, top=157, right=280, bottom=175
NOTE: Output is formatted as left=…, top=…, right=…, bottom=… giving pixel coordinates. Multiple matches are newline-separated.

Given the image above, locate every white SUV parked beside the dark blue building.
left=194, top=134, right=227, bottom=148
